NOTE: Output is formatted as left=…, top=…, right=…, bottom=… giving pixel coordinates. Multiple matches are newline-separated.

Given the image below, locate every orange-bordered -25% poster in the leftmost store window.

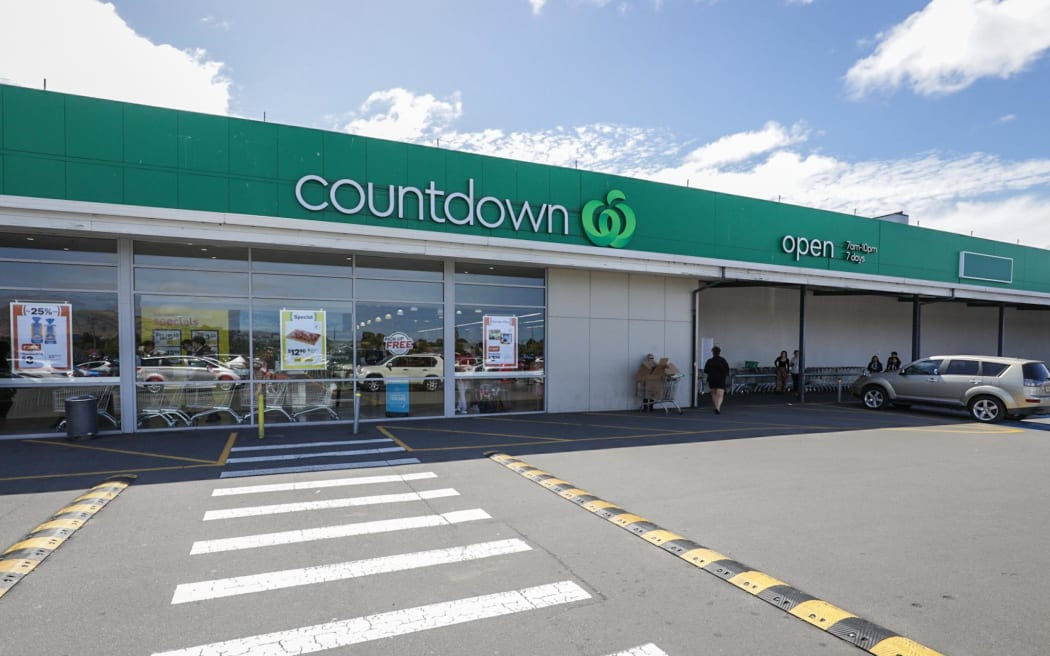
left=11, top=301, right=72, bottom=375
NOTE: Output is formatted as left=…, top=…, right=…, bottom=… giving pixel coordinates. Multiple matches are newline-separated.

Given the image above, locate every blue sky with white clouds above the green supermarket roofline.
left=6, top=0, right=1050, bottom=249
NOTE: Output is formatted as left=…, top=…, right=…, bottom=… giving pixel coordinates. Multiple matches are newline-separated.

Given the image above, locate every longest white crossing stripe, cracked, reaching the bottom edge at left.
left=153, top=580, right=590, bottom=656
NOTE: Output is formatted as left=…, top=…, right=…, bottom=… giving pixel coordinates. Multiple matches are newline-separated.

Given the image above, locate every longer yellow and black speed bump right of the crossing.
left=486, top=452, right=943, bottom=656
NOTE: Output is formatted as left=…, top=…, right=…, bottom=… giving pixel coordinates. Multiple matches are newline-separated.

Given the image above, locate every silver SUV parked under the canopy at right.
left=853, top=356, right=1050, bottom=423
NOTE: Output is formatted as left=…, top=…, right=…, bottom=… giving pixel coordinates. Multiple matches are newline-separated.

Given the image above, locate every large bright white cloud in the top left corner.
left=0, top=0, right=230, bottom=114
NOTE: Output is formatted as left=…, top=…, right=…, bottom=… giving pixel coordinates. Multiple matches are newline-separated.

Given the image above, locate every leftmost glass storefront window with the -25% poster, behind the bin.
left=0, top=227, right=120, bottom=435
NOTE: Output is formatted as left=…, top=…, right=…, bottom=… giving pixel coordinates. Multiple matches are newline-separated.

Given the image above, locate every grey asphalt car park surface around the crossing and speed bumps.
left=0, top=397, right=1050, bottom=656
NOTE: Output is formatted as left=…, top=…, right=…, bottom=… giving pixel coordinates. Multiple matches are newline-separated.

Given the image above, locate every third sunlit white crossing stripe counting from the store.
left=190, top=508, right=491, bottom=555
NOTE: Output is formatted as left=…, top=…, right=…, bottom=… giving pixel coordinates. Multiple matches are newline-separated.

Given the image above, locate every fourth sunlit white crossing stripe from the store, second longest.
left=171, top=538, right=531, bottom=604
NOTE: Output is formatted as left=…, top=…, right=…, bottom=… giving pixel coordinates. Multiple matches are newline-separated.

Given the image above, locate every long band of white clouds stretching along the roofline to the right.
left=350, top=89, right=1050, bottom=246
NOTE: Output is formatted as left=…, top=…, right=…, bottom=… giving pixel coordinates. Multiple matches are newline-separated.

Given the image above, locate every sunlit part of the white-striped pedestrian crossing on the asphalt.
left=152, top=463, right=667, bottom=656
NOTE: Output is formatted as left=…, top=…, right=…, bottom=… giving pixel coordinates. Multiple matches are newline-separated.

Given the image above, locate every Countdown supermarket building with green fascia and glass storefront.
left=0, top=85, right=1050, bottom=438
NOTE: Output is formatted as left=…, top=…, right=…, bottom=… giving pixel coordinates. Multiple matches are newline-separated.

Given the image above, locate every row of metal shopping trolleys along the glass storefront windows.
left=51, top=380, right=339, bottom=430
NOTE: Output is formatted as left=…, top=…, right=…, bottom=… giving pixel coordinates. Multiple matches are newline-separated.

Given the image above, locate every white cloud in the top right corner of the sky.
left=846, top=0, right=1050, bottom=98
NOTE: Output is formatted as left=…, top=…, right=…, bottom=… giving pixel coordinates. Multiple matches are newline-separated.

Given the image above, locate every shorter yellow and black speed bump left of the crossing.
left=0, top=474, right=138, bottom=597
